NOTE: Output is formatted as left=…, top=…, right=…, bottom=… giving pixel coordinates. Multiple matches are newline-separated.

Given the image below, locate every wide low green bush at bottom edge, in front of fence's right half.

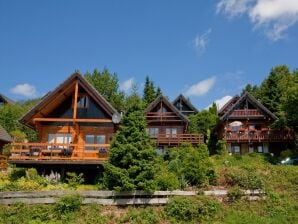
left=165, top=196, right=220, bottom=221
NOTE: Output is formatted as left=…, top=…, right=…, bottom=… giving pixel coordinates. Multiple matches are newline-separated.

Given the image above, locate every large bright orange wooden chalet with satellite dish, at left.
left=9, top=73, right=119, bottom=171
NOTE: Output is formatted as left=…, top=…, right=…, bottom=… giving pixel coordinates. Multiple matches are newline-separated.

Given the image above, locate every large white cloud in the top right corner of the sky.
left=216, top=0, right=298, bottom=41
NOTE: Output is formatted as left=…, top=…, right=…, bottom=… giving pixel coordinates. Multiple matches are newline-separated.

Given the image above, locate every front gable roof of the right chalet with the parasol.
left=220, top=92, right=277, bottom=120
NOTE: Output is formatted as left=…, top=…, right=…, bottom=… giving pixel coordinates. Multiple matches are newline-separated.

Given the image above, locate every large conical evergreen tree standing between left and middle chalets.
left=103, top=94, right=157, bottom=191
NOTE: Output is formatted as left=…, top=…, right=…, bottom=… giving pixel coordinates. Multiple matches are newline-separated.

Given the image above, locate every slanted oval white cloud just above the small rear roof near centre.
left=185, top=77, right=216, bottom=96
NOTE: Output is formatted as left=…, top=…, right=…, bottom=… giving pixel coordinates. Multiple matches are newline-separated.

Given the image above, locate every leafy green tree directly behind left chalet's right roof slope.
left=85, top=68, right=125, bottom=111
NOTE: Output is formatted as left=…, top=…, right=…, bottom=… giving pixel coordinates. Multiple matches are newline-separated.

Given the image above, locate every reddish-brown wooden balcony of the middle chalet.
left=154, top=134, right=204, bottom=146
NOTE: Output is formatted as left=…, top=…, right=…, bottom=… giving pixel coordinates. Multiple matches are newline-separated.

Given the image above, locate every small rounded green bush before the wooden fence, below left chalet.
left=54, top=195, right=82, bottom=216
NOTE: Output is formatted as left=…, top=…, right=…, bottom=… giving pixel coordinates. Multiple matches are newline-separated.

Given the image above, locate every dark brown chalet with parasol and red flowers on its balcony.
left=218, top=92, right=295, bottom=154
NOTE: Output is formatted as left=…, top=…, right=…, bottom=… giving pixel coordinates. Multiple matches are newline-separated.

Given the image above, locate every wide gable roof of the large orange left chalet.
left=20, top=72, right=117, bottom=128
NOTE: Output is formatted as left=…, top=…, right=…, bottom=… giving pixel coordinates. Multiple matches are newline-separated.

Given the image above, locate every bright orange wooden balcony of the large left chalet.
left=8, top=143, right=110, bottom=164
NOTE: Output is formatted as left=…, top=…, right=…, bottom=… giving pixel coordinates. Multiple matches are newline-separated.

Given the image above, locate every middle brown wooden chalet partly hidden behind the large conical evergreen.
left=145, top=96, right=204, bottom=153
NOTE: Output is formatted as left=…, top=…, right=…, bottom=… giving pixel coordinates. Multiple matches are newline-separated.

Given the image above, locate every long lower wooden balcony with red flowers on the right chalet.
left=224, top=130, right=295, bottom=142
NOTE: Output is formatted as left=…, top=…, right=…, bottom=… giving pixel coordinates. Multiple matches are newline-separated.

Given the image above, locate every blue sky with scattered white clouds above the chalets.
left=0, top=0, right=298, bottom=109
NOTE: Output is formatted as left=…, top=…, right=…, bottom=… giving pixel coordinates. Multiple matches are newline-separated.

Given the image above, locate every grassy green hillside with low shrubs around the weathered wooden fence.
left=0, top=154, right=298, bottom=224
